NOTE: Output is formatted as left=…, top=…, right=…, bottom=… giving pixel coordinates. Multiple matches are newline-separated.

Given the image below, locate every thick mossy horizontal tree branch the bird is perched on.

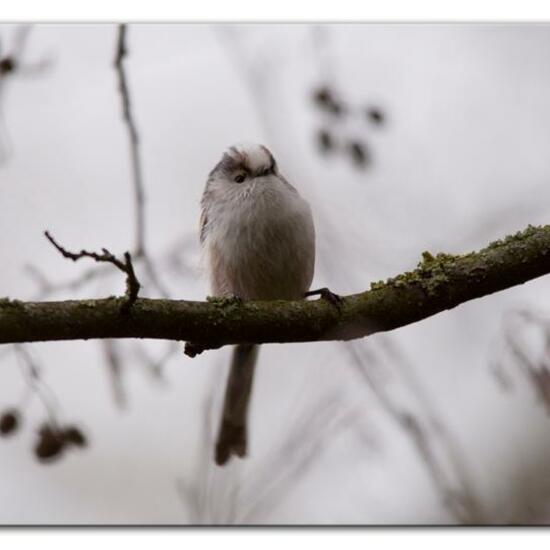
left=0, top=226, right=550, bottom=349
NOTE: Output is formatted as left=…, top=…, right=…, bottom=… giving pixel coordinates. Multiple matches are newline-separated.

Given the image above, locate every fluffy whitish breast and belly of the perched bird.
left=205, top=177, right=315, bottom=300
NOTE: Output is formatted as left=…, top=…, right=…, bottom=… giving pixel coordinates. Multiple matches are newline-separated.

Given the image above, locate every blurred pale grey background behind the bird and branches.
left=0, top=24, right=550, bottom=523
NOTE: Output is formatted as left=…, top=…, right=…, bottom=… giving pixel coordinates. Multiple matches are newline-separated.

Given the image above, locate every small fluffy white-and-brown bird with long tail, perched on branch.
left=200, top=145, right=316, bottom=465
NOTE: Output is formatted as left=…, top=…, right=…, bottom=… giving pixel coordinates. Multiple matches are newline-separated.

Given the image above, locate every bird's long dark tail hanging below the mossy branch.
left=215, top=344, right=259, bottom=466
